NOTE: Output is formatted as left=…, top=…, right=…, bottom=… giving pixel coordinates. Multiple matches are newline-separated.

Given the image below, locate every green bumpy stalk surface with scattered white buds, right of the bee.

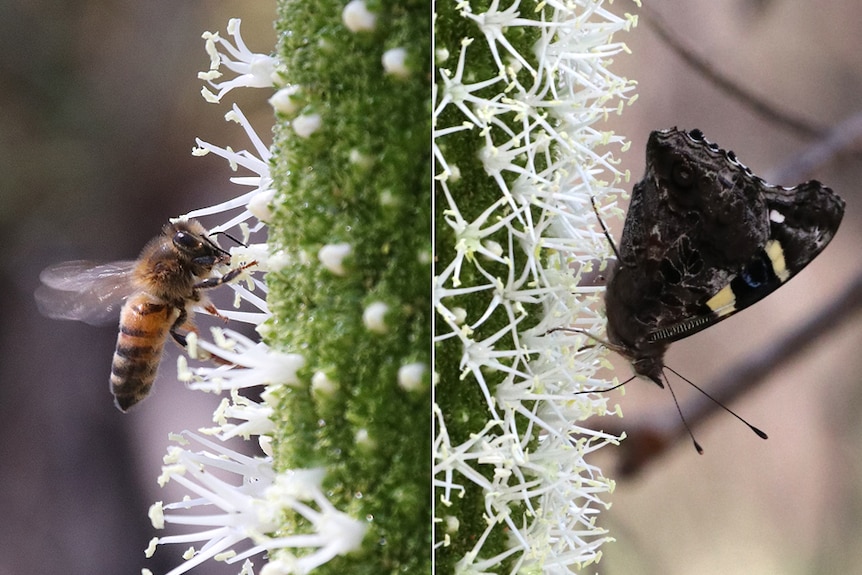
left=267, top=0, right=431, bottom=575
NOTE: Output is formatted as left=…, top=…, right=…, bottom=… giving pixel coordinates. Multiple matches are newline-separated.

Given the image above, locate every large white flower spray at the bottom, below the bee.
left=148, top=432, right=366, bottom=575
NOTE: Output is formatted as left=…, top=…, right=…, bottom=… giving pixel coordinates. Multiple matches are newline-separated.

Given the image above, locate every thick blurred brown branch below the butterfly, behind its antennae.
left=602, top=272, right=862, bottom=477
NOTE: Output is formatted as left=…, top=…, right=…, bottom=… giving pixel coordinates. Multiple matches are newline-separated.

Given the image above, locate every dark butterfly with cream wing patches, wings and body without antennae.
left=605, top=128, right=844, bottom=386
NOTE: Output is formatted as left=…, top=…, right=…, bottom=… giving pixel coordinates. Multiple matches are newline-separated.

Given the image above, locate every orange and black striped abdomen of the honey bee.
left=111, top=293, right=176, bottom=411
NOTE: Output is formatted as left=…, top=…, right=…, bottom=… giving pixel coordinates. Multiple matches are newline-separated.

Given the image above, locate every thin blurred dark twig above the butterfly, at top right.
left=641, top=3, right=825, bottom=138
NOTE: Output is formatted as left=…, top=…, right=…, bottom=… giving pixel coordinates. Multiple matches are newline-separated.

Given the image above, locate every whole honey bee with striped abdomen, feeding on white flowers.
left=36, top=220, right=257, bottom=412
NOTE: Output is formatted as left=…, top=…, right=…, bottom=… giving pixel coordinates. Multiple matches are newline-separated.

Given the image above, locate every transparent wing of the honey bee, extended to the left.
left=36, top=260, right=135, bottom=325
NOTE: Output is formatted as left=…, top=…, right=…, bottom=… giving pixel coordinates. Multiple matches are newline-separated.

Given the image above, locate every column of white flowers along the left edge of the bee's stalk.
left=144, top=19, right=366, bottom=575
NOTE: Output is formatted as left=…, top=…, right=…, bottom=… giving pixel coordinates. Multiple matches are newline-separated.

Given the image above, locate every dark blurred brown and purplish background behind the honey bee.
left=0, top=0, right=275, bottom=575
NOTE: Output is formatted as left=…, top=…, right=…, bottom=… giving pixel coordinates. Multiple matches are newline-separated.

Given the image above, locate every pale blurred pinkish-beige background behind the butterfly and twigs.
left=596, top=0, right=862, bottom=575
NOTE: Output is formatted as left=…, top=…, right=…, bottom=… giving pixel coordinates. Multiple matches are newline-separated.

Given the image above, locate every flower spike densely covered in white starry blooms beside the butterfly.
left=433, top=0, right=635, bottom=573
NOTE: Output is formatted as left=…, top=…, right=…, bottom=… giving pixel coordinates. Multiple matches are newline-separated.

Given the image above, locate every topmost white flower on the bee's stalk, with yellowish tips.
left=198, top=18, right=278, bottom=103
